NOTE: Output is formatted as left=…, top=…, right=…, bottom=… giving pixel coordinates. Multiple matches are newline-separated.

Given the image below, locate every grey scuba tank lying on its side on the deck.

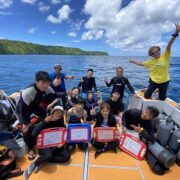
left=148, top=142, right=176, bottom=168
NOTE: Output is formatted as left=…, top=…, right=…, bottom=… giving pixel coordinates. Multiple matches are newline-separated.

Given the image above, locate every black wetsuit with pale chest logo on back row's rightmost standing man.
left=106, top=76, right=134, bottom=100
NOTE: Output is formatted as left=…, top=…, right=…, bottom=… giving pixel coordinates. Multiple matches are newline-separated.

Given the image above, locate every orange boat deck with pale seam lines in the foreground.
left=14, top=147, right=180, bottom=180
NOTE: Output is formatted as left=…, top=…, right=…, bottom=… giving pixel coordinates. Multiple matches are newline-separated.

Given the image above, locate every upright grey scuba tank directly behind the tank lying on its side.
left=156, top=116, right=174, bottom=146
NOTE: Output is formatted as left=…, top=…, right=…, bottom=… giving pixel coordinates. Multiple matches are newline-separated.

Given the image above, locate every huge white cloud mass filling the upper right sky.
left=81, top=0, right=180, bottom=50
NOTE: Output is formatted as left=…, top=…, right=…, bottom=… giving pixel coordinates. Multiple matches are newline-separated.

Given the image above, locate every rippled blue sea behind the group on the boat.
left=0, top=55, right=180, bottom=104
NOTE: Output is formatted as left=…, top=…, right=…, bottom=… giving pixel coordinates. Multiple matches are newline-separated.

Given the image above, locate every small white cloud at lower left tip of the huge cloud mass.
left=81, top=30, right=104, bottom=40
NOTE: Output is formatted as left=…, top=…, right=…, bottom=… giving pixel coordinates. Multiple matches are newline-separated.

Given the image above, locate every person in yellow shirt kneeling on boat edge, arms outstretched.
left=129, top=23, right=180, bottom=100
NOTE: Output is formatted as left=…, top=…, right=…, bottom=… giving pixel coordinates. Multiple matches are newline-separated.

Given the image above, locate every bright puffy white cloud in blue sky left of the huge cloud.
left=47, top=5, right=71, bottom=24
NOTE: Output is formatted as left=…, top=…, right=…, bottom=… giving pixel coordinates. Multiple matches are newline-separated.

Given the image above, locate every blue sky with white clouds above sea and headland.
left=0, top=0, right=180, bottom=56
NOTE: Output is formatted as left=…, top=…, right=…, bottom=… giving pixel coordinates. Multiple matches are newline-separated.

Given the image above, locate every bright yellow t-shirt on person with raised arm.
left=143, top=51, right=171, bottom=83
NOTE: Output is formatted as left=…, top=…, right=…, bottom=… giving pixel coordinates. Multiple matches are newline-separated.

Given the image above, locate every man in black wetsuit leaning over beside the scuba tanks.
left=122, top=106, right=166, bottom=175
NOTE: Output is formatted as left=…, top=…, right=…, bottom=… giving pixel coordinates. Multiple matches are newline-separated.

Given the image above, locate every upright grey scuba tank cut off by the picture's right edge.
left=168, top=129, right=180, bottom=152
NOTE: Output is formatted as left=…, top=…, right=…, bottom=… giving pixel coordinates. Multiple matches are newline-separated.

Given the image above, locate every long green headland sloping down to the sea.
left=0, top=39, right=109, bottom=56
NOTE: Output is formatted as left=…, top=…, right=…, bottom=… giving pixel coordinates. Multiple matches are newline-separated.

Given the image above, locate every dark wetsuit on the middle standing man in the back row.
left=78, top=76, right=97, bottom=93
